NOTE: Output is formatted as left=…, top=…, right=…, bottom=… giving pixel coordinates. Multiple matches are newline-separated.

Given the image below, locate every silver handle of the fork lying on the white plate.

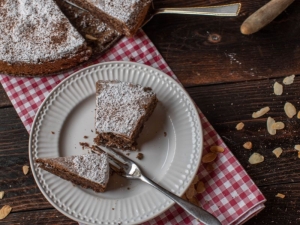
left=140, top=175, right=221, bottom=225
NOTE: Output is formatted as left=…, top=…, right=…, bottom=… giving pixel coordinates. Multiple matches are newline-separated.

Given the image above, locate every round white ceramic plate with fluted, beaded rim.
left=29, top=62, right=203, bottom=225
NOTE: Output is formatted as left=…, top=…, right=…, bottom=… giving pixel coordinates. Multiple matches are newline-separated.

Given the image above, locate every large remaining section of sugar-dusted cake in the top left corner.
left=0, top=0, right=92, bottom=76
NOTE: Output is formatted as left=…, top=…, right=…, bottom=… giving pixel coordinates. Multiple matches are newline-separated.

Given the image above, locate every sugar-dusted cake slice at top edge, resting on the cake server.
left=70, top=0, right=152, bottom=36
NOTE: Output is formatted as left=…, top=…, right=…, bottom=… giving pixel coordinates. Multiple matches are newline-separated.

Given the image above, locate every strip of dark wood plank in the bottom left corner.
left=0, top=209, right=78, bottom=225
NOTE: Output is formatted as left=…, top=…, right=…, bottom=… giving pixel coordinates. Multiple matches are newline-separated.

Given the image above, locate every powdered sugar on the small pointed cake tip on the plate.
left=73, top=153, right=109, bottom=185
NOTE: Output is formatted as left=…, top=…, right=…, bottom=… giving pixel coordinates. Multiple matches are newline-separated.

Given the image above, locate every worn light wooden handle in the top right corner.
left=241, top=0, right=294, bottom=35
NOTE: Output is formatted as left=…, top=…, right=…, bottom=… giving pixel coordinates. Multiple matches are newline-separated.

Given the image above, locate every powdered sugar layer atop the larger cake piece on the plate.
left=96, top=81, right=155, bottom=137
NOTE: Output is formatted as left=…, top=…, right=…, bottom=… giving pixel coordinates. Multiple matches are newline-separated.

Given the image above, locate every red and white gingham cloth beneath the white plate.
left=0, top=31, right=266, bottom=225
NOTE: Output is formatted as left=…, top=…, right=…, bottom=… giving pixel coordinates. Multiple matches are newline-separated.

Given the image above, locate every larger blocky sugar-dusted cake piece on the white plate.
left=94, top=80, right=157, bottom=150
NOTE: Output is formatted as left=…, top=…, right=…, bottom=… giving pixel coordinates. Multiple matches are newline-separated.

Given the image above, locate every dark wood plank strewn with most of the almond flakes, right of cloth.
left=187, top=76, right=300, bottom=186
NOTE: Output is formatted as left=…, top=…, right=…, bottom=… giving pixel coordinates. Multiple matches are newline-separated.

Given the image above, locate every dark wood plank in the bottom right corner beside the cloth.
left=245, top=183, right=300, bottom=225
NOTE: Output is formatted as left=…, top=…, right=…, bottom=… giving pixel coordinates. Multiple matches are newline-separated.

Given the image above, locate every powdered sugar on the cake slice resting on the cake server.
left=89, top=0, right=151, bottom=27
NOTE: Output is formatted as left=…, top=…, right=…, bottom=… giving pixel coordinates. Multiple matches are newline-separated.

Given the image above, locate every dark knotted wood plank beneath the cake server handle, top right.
left=144, top=0, right=300, bottom=86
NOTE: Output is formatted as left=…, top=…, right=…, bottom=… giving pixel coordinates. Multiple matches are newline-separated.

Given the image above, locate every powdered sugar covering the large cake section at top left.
left=0, top=0, right=84, bottom=63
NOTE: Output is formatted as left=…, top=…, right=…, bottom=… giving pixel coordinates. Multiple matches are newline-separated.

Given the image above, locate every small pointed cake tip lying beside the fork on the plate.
left=35, top=152, right=109, bottom=192
